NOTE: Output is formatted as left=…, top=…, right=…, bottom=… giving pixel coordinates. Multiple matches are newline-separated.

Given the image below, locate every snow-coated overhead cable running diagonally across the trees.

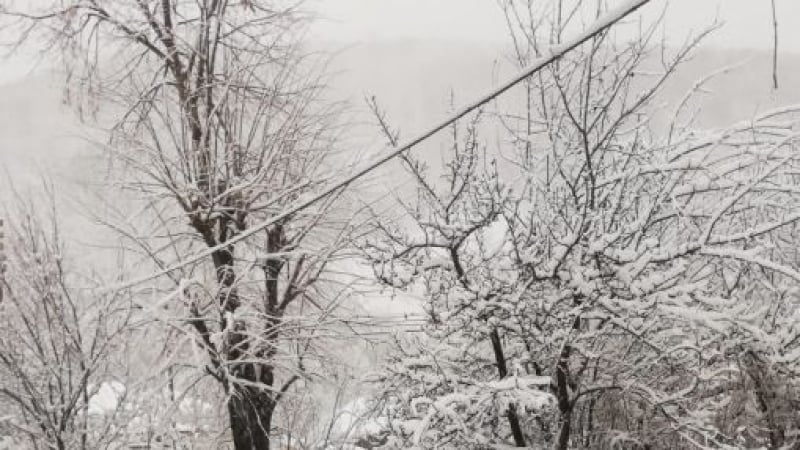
left=107, top=0, right=650, bottom=291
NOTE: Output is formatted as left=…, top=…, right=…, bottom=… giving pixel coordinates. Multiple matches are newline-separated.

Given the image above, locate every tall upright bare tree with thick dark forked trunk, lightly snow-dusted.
left=3, top=0, right=349, bottom=449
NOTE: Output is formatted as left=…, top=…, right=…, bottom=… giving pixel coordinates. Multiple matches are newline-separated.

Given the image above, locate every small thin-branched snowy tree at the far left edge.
left=0, top=194, right=131, bottom=450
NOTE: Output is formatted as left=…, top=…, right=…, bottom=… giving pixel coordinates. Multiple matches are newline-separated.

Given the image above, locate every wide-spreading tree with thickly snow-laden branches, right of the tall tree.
left=363, top=2, right=800, bottom=449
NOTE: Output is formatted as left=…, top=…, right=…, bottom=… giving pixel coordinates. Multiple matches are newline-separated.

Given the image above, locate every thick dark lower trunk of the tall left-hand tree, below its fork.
left=228, top=386, right=275, bottom=450
